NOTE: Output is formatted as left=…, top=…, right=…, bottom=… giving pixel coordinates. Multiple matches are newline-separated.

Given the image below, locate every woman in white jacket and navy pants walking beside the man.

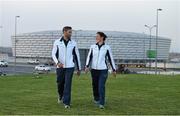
left=85, top=32, right=116, bottom=109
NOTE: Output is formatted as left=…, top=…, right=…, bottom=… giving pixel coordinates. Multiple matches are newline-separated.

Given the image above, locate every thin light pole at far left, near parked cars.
left=14, top=16, right=20, bottom=74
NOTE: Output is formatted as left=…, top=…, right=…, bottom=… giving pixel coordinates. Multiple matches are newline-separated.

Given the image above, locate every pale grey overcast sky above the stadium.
left=0, top=0, right=180, bottom=52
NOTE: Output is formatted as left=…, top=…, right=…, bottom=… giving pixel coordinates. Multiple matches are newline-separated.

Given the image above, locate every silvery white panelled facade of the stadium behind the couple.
left=11, top=30, right=171, bottom=70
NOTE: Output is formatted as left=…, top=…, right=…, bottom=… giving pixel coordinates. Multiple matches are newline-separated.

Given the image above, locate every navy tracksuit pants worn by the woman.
left=91, top=69, right=108, bottom=105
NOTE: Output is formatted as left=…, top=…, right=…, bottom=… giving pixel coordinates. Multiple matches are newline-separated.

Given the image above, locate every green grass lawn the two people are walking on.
left=0, top=74, right=180, bottom=115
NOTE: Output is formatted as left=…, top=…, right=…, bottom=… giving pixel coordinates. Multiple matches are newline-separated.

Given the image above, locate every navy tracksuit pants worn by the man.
left=56, top=68, right=74, bottom=105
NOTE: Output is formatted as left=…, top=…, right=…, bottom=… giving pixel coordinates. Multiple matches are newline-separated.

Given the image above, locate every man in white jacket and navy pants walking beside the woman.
left=52, top=26, right=81, bottom=108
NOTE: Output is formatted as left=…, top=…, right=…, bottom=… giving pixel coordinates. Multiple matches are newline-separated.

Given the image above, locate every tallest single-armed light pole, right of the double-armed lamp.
left=155, top=8, right=162, bottom=75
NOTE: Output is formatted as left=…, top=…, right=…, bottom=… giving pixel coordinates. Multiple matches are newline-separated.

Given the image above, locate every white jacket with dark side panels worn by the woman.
left=86, top=43, right=116, bottom=71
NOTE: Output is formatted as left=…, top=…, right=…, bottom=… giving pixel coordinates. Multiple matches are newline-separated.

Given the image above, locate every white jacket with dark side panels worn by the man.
left=52, top=37, right=81, bottom=70
